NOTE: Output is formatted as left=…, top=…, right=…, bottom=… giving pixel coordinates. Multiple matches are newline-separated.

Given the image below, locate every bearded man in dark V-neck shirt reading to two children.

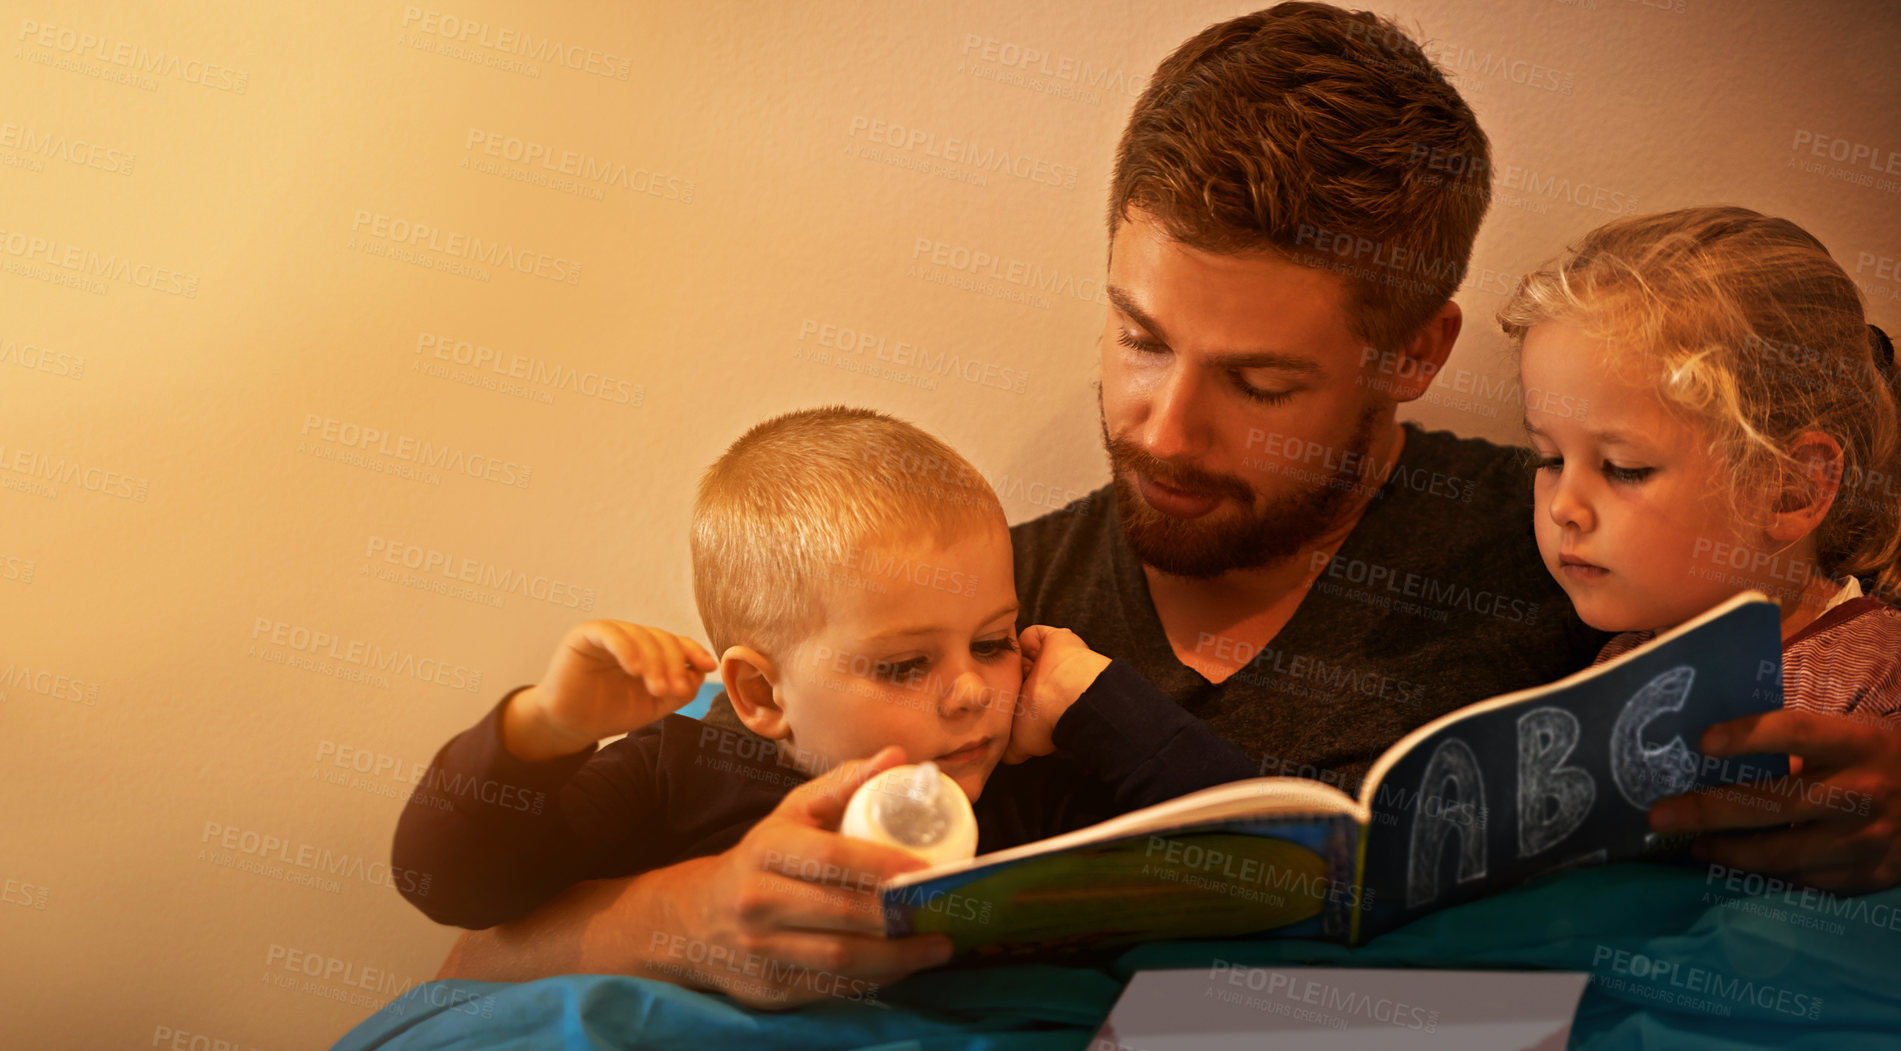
left=427, top=4, right=1901, bottom=1007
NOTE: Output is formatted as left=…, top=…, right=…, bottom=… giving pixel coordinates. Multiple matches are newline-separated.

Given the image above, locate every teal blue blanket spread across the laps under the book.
left=336, top=865, right=1901, bottom=1051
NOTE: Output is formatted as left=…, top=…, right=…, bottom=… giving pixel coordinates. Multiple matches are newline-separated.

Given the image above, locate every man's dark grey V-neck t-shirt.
left=1009, top=424, right=1610, bottom=791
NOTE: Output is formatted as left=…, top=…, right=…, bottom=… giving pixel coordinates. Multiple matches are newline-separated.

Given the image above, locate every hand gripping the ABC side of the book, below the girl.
left=1650, top=709, right=1901, bottom=893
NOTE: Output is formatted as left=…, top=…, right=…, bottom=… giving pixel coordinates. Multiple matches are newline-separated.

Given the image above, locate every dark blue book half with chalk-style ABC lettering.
left=1361, top=591, right=1789, bottom=937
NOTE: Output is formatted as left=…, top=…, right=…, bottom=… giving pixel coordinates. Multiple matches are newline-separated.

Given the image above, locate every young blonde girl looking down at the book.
left=1498, top=207, right=1901, bottom=718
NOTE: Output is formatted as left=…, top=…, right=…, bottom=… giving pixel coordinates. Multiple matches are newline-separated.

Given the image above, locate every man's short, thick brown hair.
left=1108, top=4, right=1492, bottom=350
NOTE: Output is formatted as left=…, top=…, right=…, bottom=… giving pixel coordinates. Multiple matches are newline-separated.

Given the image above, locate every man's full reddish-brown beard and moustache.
left=1099, top=401, right=1378, bottom=580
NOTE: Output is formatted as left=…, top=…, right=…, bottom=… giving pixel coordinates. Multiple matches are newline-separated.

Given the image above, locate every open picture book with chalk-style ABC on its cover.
left=882, top=591, right=1789, bottom=956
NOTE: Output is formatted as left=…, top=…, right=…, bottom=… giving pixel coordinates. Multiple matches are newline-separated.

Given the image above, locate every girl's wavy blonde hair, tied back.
left=1498, top=207, right=1901, bottom=599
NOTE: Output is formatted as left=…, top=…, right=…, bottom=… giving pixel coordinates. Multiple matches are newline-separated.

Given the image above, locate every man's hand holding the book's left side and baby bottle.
left=643, top=745, right=951, bottom=1009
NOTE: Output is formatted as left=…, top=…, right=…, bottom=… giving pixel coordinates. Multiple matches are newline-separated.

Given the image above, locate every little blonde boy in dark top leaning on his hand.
left=394, top=409, right=1255, bottom=927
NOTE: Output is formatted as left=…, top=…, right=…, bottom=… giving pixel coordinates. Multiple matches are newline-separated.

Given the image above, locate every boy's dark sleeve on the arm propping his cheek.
left=1051, top=661, right=1260, bottom=812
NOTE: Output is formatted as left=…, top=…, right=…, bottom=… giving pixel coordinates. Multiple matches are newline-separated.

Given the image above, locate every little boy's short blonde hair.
left=692, top=407, right=1006, bottom=658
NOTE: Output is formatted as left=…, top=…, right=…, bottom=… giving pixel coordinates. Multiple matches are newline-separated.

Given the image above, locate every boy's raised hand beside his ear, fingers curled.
left=502, top=620, right=719, bottom=760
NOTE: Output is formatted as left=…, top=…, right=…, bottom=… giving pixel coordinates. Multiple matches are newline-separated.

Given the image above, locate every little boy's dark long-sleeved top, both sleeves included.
left=392, top=661, right=1257, bottom=929
